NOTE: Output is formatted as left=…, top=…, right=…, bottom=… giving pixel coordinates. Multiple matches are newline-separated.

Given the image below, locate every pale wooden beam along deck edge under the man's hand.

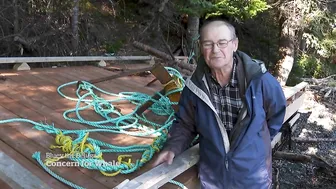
left=115, top=144, right=199, bottom=189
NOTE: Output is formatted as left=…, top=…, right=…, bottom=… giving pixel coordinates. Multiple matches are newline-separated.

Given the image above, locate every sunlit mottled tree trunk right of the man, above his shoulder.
left=275, top=18, right=295, bottom=86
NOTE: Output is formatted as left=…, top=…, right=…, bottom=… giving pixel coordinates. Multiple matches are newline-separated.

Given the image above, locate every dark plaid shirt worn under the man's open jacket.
left=208, top=59, right=242, bottom=133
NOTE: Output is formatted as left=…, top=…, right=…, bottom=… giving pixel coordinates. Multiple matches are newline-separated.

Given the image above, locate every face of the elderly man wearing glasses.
left=201, top=22, right=238, bottom=69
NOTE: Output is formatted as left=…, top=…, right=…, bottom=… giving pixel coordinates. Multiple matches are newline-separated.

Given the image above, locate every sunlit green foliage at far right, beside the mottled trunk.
left=288, top=0, right=336, bottom=84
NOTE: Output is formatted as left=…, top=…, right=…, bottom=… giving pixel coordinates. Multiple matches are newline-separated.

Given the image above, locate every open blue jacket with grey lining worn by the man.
left=165, top=51, right=286, bottom=189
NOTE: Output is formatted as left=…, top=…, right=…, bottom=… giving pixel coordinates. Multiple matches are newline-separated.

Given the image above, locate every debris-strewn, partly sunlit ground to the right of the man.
left=273, top=88, right=336, bottom=189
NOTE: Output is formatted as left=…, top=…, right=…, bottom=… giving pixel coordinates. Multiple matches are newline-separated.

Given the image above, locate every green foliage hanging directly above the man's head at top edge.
left=176, top=0, right=269, bottom=19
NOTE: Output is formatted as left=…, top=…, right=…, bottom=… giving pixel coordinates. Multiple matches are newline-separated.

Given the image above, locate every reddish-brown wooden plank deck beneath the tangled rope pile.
left=0, top=64, right=196, bottom=189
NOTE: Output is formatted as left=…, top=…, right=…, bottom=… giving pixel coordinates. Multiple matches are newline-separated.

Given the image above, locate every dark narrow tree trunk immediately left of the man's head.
left=187, top=16, right=199, bottom=62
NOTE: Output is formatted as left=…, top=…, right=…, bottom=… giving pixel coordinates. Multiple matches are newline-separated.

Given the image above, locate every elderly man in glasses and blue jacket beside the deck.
left=153, top=20, right=286, bottom=189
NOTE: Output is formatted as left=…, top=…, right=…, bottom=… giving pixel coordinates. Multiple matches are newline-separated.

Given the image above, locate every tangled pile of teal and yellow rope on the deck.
left=0, top=67, right=185, bottom=189
